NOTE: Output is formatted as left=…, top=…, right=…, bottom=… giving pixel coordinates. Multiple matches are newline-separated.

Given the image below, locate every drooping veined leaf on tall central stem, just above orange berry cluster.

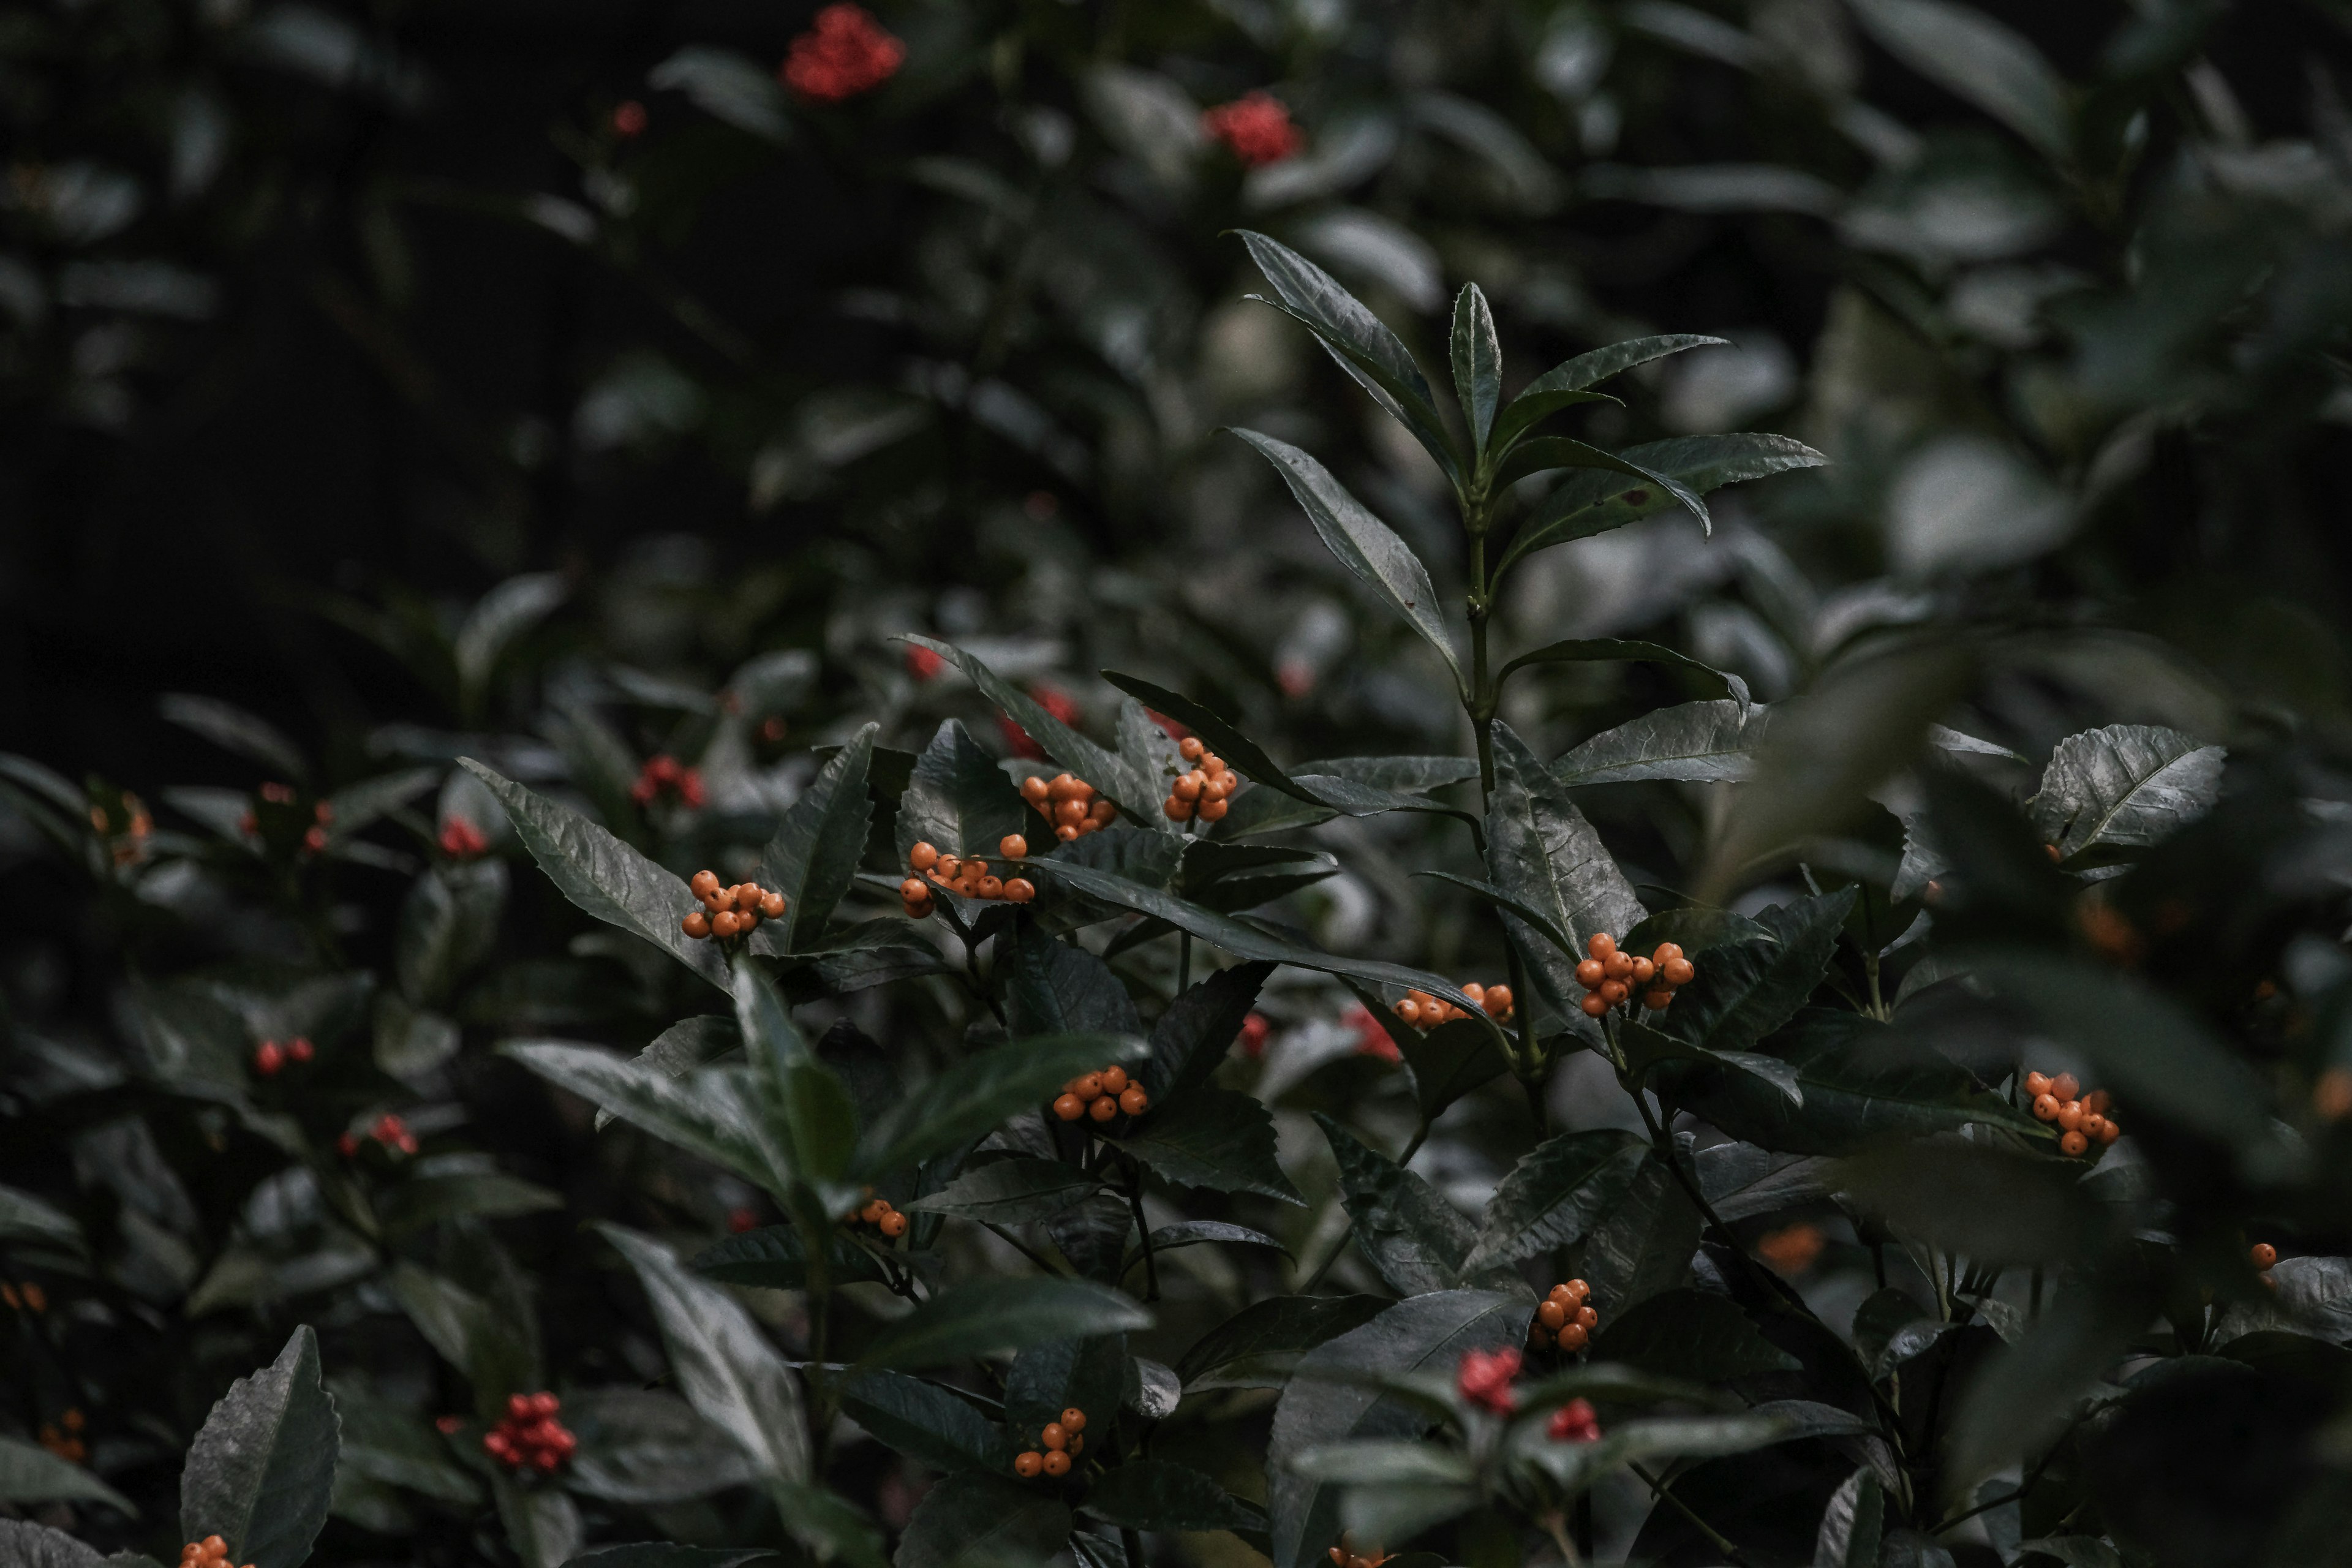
left=1487, top=722, right=1646, bottom=1009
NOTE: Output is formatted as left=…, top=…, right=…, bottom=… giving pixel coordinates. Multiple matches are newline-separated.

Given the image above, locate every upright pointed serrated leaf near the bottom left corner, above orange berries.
left=179, top=1324, right=341, bottom=1568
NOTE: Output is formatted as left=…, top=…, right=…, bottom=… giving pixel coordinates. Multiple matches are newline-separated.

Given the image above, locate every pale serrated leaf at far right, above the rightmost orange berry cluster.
left=2030, top=724, right=2225, bottom=861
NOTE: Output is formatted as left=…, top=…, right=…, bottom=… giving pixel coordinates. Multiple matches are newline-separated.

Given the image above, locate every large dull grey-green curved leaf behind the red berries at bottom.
left=1265, top=1291, right=1534, bottom=1568
